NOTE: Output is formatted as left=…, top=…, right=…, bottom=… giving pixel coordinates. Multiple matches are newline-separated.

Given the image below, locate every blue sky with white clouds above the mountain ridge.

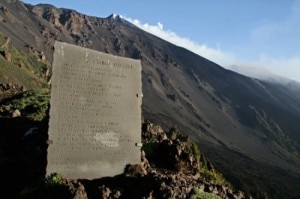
left=23, top=0, right=300, bottom=82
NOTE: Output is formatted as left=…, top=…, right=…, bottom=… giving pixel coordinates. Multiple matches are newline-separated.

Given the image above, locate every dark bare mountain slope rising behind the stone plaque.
left=0, top=0, right=300, bottom=196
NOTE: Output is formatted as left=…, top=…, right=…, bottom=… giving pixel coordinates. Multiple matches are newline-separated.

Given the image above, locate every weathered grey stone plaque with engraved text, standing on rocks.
left=47, top=42, right=142, bottom=179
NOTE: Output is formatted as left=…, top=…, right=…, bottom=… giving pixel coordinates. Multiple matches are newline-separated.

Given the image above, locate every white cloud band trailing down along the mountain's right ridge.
left=122, top=15, right=300, bottom=82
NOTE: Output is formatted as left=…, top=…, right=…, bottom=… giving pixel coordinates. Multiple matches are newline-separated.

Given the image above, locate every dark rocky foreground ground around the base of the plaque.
left=0, top=111, right=247, bottom=199
